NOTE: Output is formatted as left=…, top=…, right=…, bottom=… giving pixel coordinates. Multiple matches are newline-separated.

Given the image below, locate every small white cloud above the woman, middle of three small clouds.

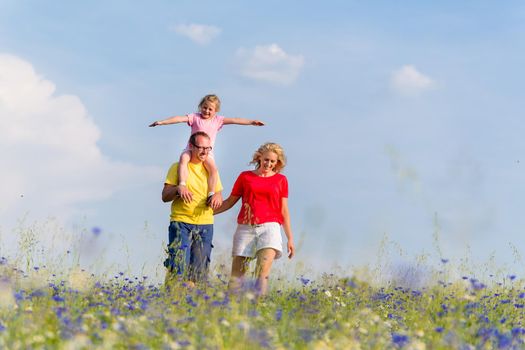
left=236, top=44, right=304, bottom=85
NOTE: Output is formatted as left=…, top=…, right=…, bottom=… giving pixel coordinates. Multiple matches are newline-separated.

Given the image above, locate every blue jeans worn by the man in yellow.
left=164, top=221, right=213, bottom=281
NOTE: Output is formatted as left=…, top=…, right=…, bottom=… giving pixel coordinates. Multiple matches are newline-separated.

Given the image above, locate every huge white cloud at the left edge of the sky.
left=0, top=54, right=160, bottom=223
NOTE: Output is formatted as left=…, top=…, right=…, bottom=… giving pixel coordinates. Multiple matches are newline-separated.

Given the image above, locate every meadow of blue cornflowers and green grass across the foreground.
left=0, top=258, right=525, bottom=349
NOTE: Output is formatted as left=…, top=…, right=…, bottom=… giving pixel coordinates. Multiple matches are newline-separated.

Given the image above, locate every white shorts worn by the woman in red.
left=232, top=222, right=283, bottom=259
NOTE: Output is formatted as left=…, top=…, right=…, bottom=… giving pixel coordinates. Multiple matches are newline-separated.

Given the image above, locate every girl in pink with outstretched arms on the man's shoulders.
left=150, top=95, right=264, bottom=202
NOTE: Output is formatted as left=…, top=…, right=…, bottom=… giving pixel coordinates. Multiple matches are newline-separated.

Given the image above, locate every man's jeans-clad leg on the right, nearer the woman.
left=189, top=225, right=213, bottom=282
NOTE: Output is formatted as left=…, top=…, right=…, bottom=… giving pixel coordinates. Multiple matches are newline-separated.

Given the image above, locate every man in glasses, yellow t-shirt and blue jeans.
left=162, top=131, right=222, bottom=285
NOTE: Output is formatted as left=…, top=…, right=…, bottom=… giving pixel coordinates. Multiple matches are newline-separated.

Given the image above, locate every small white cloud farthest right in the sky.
left=390, top=65, right=435, bottom=96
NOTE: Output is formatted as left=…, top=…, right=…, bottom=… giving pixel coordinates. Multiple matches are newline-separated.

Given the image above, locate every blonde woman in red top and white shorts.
left=215, top=143, right=295, bottom=294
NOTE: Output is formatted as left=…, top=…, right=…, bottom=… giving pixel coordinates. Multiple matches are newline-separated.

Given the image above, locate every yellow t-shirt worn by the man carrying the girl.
left=165, top=162, right=222, bottom=225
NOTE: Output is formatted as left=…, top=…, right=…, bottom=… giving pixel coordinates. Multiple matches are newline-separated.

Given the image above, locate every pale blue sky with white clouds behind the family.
left=0, top=0, right=525, bottom=278
